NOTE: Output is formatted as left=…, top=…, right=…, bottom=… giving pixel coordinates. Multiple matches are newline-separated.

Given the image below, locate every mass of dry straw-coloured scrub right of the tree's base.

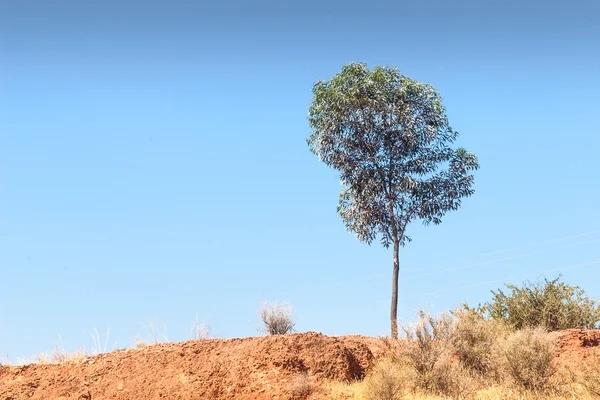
left=361, top=310, right=584, bottom=399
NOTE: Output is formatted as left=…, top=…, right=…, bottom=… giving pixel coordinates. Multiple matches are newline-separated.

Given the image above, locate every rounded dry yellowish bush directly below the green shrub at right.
left=499, top=328, right=556, bottom=391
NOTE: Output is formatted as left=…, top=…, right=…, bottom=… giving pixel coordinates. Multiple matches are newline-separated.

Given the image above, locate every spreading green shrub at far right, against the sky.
left=478, top=275, right=600, bottom=331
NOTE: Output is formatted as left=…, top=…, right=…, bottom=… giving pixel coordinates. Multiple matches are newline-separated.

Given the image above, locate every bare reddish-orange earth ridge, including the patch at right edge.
left=0, top=330, right=600, bottom=400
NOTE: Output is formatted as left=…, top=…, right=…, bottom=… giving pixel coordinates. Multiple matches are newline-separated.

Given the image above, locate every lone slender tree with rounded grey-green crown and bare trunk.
left=307, top=63, right=479, bottom=338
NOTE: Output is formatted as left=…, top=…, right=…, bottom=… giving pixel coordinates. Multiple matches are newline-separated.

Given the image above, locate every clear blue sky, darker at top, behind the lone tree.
left=0, top=0, right=600, bottom=363
